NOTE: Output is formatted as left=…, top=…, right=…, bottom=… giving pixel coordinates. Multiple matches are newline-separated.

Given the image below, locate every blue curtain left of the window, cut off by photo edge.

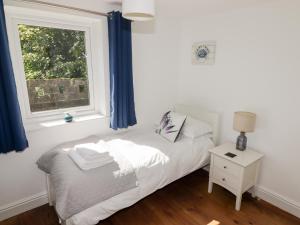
left=0, top=0, right=28, bottom=153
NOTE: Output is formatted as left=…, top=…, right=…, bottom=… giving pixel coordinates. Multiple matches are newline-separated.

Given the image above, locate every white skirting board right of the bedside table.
left=255, top=186, right=300, bottom=218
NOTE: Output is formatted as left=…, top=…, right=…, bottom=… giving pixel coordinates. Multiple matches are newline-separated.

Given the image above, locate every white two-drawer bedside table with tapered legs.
left=208, top=143, right=263, bottom=211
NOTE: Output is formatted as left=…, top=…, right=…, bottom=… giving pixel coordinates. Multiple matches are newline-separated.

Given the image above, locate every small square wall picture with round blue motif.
left=192, top=41, right=216, bottom=65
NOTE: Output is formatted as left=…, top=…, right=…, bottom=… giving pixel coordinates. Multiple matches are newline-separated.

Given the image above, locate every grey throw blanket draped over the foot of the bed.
left=37, top=137, right=137, bottom=220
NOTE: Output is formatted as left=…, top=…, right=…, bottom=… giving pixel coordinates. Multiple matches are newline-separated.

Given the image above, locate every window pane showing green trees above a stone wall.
left=18, top=24, right=90, bottom=112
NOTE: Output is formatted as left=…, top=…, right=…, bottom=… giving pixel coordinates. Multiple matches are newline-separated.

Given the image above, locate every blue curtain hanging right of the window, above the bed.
left=108, top=12, right=136, bottom=130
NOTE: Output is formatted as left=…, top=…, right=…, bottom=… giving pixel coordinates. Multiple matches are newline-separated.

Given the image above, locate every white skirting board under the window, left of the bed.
left=0, top=192, right=48, bottom=221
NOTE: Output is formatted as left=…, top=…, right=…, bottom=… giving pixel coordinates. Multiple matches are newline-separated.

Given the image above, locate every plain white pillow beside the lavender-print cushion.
left=181, top=116, right=213, bottom=138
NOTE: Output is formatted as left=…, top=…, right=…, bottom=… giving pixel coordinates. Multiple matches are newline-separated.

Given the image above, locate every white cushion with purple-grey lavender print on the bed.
left=156, top=111, right=186, bottom=142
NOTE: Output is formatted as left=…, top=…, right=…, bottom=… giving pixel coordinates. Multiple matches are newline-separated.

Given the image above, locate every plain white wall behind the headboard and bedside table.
left=178, top=0, right=300, bottom=216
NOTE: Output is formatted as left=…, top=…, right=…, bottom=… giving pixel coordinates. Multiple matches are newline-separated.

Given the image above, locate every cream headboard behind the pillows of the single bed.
left=174, top=104, right=219, bottom=144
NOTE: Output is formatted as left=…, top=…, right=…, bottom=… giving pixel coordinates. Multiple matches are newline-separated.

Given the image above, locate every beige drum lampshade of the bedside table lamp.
left=233, top=112, right=256, bottom=133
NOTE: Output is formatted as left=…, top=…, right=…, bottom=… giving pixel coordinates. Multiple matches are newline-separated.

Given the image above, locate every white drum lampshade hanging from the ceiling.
left=122, top=0, right=155, bottom=21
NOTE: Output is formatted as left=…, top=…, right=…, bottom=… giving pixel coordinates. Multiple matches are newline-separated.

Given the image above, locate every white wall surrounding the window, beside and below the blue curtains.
left=0, top=0, right=178, bottom=220
